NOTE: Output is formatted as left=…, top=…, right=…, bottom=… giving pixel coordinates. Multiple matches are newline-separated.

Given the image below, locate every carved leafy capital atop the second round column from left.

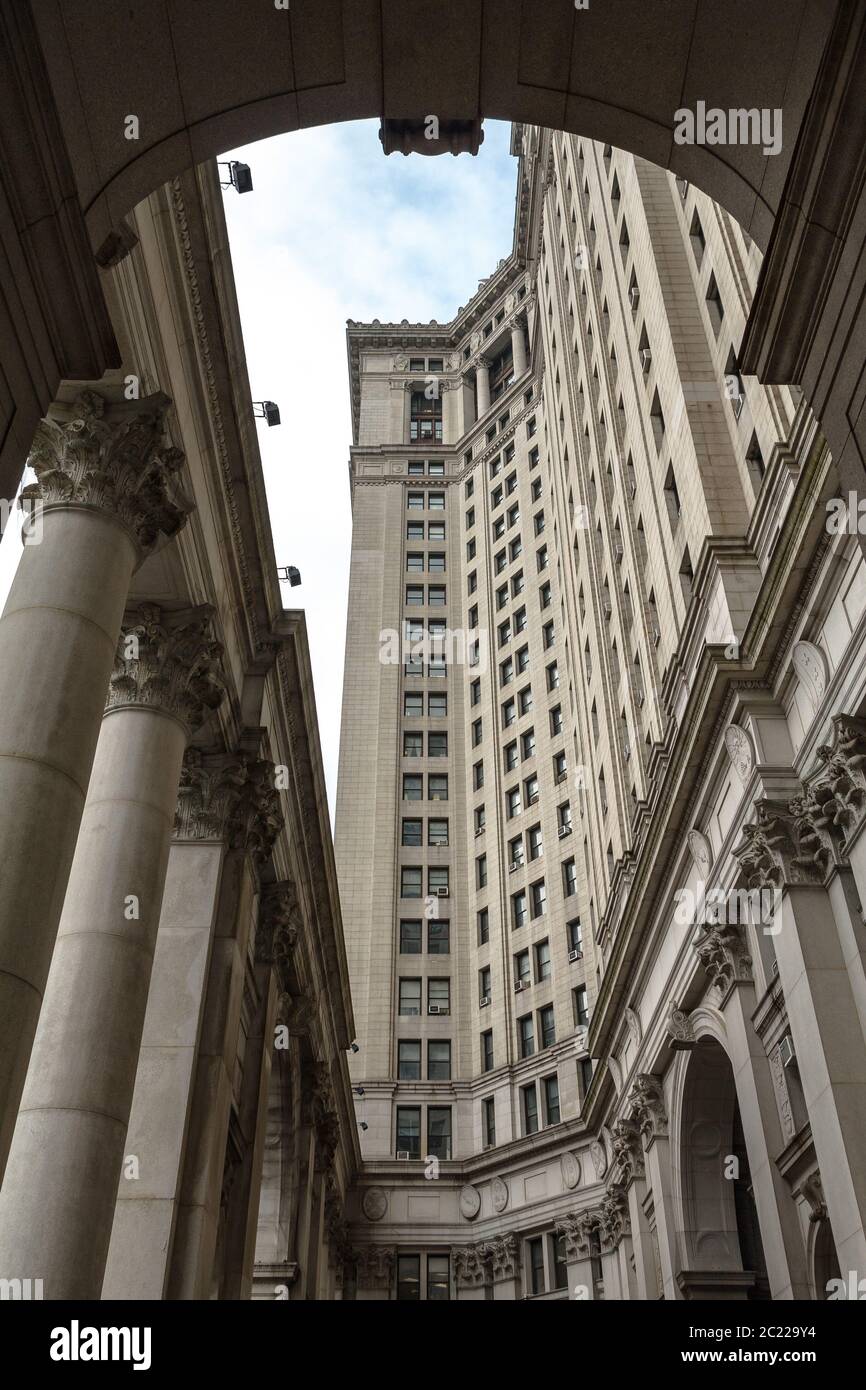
left=106, top=603, right=224, bottom=733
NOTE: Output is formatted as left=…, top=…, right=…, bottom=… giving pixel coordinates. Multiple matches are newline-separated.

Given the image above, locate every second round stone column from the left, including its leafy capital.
left=0, top=605, right=222, bottom=1298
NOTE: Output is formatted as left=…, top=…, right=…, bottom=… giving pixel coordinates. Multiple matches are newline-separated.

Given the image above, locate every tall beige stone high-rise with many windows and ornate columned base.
left=336, top=125, right=866, bottom=1300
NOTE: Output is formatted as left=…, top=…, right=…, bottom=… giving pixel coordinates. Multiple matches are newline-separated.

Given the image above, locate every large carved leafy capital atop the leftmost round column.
left=22, top=391, right=192, bottom=553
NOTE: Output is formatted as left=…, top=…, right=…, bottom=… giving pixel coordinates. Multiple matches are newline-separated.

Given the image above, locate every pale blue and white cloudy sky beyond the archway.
left=0, top=121, right=517, bottom=808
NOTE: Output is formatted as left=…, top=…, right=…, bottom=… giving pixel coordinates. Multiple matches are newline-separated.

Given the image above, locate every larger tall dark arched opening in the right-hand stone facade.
left=678, top=1037, right=769, bottom=1300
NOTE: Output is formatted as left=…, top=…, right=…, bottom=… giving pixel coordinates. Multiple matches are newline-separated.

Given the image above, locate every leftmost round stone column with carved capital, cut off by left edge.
left=0, top=392, right=189, bottom=1177
